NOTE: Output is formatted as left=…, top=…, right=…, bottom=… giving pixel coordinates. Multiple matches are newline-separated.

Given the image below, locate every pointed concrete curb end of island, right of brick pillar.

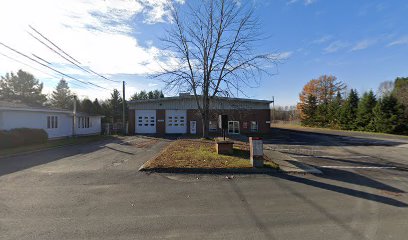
left=264, top=149, right=323, bottom=174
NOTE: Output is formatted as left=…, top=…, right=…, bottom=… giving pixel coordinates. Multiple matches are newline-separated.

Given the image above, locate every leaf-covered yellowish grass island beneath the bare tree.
left=144, top=139, right=277, bottom=170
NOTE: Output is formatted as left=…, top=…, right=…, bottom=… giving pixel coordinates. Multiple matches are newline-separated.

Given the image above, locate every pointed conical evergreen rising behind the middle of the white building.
left=50, top=79, right=74, bottom=109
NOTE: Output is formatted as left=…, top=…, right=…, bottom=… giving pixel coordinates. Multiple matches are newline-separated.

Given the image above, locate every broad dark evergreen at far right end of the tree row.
left=373, top=95, right=407, bottom=134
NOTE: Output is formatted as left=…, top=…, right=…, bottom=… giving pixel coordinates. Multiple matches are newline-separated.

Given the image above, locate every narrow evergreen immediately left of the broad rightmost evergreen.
left=356, top=90, right=377, bottom=131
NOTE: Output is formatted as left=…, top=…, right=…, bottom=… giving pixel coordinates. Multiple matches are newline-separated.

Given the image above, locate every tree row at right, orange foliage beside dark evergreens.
left=297, top=75, right=408, bottom=134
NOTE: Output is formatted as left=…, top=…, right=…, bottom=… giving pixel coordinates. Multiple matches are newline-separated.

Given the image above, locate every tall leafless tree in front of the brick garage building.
left=156, top=0, right=279, bottom=138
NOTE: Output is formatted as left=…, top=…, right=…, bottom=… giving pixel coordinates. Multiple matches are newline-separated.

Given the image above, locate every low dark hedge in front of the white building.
left=0, top=128, right=48, bottom=149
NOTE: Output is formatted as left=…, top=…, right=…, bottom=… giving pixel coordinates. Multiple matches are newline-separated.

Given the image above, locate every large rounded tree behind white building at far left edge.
left=0, top=70, right=47, bottom=106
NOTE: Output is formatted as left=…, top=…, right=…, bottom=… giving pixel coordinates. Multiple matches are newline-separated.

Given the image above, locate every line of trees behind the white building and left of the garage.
left=0, top=70, right=164, bottom=123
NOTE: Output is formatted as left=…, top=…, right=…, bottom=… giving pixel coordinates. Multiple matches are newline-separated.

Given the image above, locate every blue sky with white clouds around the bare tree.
left=0, top=0, right=408, bottom=106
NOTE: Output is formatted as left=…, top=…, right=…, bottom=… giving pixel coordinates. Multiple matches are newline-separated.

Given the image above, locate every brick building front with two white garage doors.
left=128, top=94, right=271, bottom=135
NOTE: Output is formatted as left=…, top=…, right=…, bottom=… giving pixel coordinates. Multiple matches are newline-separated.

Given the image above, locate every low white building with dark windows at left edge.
left=0, top=101, right=103, bottom=139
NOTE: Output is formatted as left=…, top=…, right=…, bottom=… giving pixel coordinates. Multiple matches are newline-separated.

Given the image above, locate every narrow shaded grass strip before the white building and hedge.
left=0, top=135, right=112, bottom=157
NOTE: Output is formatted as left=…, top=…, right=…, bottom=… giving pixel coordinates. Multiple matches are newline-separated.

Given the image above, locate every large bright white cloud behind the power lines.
left=0, top=0, right=184, bottom=99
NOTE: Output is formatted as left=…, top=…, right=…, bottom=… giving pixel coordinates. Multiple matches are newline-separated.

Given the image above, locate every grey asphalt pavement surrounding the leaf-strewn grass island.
left=0, top=130, right=408, bottom=239
